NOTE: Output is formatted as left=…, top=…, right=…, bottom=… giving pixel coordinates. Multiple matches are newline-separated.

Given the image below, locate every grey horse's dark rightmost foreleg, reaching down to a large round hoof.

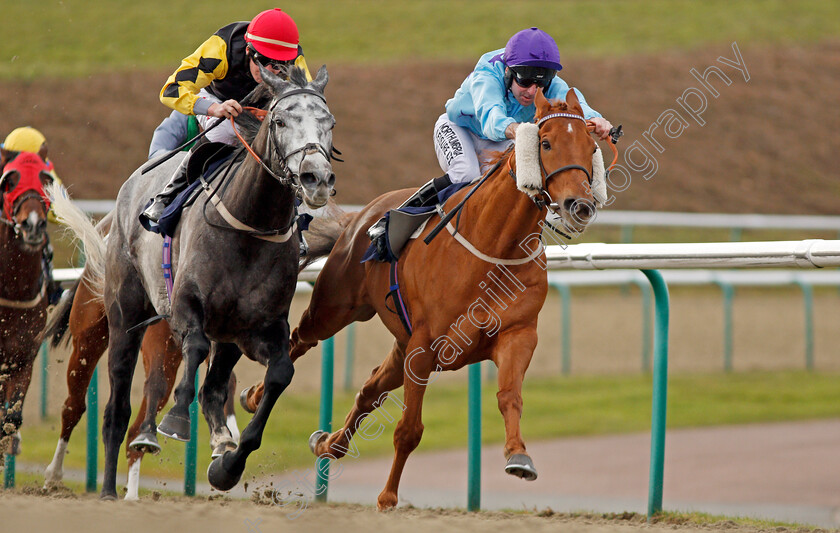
left=207, top=320, right=295, bottom=490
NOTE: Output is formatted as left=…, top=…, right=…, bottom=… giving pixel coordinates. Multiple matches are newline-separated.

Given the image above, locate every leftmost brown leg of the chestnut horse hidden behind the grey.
left=44, top=283, right=108, bottom=488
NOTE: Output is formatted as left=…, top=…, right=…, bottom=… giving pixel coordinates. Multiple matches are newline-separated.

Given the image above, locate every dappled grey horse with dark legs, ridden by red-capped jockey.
left=56, top=67, right=335, bottom=499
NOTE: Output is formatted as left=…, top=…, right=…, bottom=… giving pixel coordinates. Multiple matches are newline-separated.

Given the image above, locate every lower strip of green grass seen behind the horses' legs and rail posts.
left=20, top=371, right=840, bottom=479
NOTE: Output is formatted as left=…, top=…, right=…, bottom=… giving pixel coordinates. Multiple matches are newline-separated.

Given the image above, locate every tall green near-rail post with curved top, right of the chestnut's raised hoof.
left=642, top=270, right=670, bottom=519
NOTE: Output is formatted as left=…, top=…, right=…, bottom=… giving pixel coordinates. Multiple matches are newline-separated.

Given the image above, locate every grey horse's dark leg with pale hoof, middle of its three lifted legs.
left=198, top=344, right=242, bottom=458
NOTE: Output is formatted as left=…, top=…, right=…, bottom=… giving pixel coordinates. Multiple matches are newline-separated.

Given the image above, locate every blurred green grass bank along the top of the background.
left=0, top=0, right=840, bottom=79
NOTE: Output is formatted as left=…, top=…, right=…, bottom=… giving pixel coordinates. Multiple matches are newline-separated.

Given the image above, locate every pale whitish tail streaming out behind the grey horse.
left=46, top=184, right=110, bottom=298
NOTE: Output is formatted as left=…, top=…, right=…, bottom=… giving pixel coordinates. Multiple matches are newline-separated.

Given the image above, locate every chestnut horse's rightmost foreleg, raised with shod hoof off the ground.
left=493, top=326, right=537, bottom=481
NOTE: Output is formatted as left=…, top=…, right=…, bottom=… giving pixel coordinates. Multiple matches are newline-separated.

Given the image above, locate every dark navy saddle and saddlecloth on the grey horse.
left=144, top=142, right=240, bottom=237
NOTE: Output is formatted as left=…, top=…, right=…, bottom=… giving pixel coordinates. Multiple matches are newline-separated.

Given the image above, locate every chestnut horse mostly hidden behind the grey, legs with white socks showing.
left=43, top=242, right=239, bottom=500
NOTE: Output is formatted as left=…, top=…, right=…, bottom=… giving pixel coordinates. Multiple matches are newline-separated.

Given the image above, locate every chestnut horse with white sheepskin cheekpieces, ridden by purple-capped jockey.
left=276, top=91, right=595, bottom=509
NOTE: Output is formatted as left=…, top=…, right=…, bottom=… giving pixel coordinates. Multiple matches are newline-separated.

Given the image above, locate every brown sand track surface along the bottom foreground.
left=0, top=493, right=787, bottom=533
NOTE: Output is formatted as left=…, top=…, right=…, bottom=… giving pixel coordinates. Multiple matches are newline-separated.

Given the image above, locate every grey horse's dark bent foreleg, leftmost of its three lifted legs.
left=157, top=316, right=210, bottom=442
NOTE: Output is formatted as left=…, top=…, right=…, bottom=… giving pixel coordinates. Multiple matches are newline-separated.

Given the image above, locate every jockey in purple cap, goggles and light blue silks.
left=368, top=28, right=612, bottom=241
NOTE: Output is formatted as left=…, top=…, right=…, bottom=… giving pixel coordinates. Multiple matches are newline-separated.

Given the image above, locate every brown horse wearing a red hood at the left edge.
left=0, top=152, right=52, bottom=455
